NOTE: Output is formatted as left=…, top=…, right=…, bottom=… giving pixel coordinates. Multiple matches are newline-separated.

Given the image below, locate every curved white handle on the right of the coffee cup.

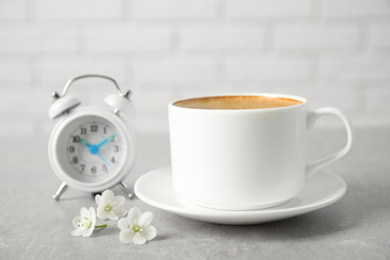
left=306, top=107, right=354, bottom=176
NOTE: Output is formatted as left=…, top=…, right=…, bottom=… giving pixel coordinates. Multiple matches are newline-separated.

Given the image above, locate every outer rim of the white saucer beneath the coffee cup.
left=134, top=166, right=347, bottom=223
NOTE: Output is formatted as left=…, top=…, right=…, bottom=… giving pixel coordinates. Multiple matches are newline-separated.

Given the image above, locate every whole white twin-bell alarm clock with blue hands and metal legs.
left=49, top=75, right=135, bottom=200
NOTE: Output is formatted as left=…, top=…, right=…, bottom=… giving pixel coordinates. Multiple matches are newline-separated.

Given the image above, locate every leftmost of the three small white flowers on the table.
left=72, top=207, right=96, bottom=237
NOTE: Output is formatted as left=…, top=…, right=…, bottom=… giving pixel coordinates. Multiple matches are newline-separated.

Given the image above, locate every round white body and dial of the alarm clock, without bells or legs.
left=49, top=109, right=135, bottom=188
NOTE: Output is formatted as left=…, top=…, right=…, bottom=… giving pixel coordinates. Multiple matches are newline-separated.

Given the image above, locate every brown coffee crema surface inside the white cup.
left=173, top=96, right=303, bottom=109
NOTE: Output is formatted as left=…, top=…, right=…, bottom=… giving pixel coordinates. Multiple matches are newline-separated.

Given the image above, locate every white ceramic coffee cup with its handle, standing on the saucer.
left=169, top=94, right=353, bottom=210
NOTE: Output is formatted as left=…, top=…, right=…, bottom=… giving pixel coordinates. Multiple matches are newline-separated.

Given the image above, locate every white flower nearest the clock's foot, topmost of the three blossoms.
left=95, top=190, right=126, bottom=220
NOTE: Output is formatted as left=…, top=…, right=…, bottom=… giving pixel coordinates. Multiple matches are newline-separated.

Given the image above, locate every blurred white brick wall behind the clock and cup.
left=0, top=0, right=390, bottom=135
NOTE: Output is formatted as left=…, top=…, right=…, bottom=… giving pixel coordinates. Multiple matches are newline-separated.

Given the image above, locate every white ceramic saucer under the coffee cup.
left=134, top=167, right=347, bottom=225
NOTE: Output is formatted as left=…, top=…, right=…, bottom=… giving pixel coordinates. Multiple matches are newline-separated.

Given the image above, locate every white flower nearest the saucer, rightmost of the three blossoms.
left=118, top=208, right=157, bottom=245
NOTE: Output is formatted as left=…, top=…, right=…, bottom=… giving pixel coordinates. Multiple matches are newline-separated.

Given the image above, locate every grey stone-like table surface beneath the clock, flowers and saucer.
left=0, top=127, right=390, bottom=259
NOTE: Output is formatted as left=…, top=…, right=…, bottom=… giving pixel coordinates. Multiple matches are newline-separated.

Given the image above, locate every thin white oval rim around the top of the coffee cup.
left=168, top=92, right=308, bottom=112
